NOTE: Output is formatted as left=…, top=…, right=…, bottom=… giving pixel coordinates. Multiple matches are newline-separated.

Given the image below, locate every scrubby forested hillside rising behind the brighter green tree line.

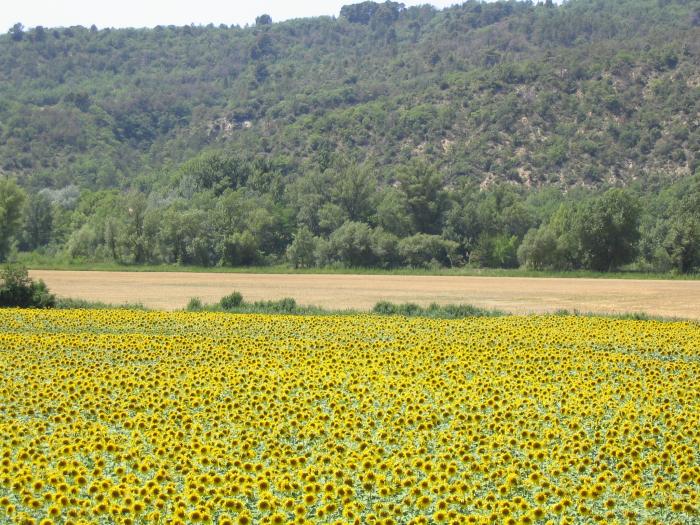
left=0, top=0, right=700, bottom=191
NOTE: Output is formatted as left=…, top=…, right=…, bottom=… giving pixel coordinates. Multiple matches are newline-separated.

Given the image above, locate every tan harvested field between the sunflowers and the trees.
left=30, top=270, right=700, bottom=319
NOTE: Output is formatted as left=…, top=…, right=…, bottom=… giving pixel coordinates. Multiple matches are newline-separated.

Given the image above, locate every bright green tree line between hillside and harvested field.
left=0, top=157, right=700, bottom=273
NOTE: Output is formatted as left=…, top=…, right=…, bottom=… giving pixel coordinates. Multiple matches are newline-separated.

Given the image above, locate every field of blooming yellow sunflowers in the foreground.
left=0, top=309, right=700, bottom=525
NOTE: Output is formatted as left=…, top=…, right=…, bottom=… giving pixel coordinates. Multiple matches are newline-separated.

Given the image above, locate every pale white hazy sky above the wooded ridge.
left=0, top=0, right=461, bottom=32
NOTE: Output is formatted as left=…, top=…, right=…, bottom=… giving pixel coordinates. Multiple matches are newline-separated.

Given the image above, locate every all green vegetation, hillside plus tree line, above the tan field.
left=0, top=0, right=700, bottom=272
